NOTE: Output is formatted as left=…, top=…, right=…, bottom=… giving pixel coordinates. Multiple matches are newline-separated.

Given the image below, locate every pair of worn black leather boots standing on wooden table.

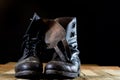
left=15, top=13, right=80, bottom=79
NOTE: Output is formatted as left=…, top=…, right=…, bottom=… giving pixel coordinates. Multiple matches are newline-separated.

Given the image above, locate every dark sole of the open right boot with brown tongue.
left=45, top=70, right=79, bottom=79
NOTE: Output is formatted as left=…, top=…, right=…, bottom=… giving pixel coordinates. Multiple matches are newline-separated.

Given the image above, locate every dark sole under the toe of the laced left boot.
left=15, top=70, right=42, bottom=79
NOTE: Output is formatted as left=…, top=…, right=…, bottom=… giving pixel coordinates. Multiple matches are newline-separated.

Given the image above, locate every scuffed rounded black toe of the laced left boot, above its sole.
left=15, top=56, right=42, bottom=72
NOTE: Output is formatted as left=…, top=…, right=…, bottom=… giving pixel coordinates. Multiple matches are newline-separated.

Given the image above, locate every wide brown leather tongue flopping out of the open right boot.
left=45, top=21, right=66, bottom=48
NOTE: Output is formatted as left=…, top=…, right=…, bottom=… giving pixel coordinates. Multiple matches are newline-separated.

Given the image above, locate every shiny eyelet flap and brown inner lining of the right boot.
left=55, top=17, right=80, bottom=64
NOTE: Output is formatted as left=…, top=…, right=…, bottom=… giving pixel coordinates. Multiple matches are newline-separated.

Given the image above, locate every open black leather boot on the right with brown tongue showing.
left=45, top=17, right=80, bottom=79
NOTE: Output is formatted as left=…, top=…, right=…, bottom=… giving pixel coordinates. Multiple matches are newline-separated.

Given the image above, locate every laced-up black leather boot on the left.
left=15, top=13, right=43, bottom=79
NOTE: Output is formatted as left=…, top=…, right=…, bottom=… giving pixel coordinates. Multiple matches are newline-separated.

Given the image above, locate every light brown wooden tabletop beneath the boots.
left=0, top=62, right=120, bottom=80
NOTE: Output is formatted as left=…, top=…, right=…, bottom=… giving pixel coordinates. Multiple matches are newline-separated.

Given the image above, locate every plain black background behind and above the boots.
left=0, top=0, right=120, bottom=66
